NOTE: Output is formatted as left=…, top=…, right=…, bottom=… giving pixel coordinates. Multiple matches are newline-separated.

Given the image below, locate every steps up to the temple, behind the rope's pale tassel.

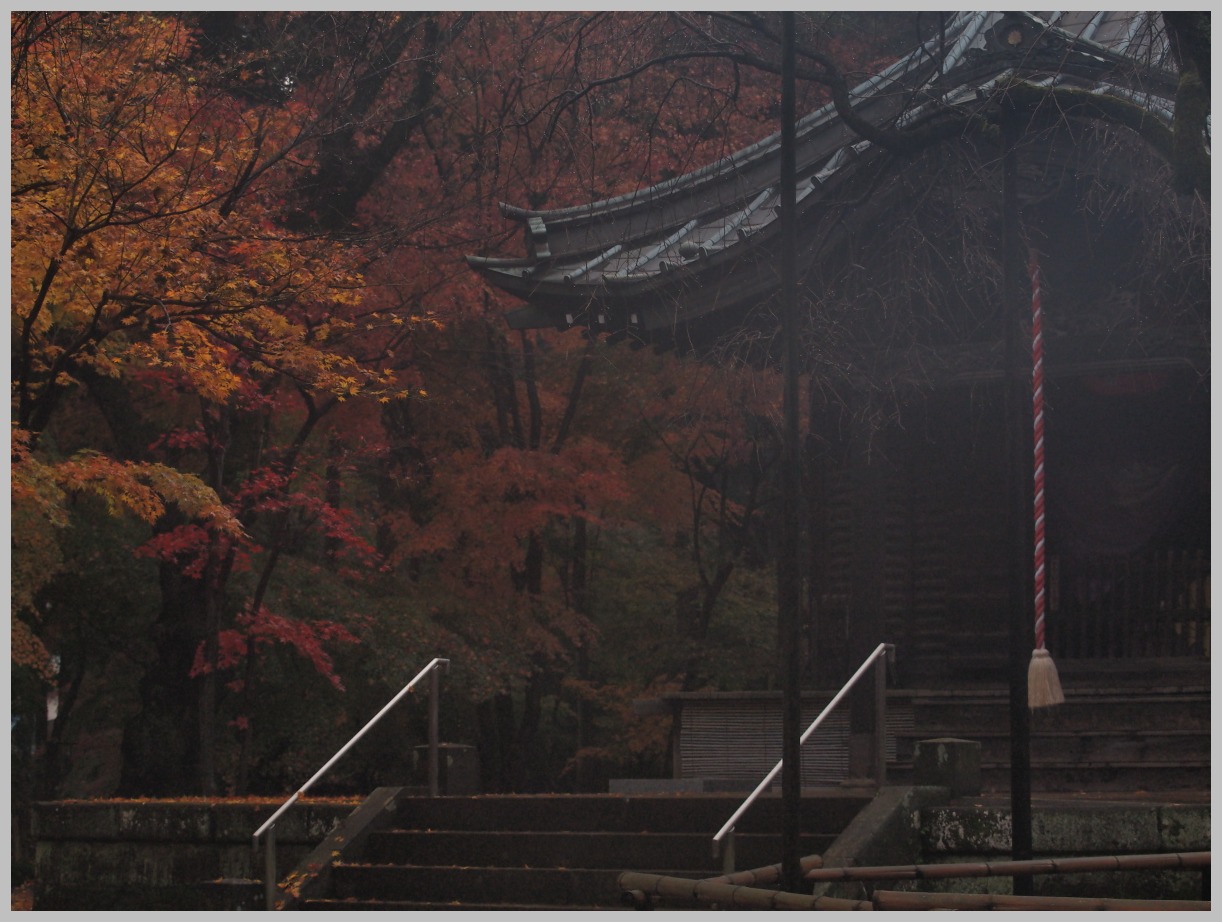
left=888, top=659, right=1211, bottom=793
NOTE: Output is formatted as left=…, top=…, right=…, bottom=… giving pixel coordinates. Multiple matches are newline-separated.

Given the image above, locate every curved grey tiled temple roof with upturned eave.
left=468, top=12, right=1177, bottom=338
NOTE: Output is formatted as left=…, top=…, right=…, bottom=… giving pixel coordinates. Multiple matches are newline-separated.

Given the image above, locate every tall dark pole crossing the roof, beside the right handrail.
left=776, top=12, right=802, bottom=893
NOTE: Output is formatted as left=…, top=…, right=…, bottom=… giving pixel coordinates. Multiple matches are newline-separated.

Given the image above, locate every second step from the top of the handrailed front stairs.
left=362, top=821, right=836, bottom=876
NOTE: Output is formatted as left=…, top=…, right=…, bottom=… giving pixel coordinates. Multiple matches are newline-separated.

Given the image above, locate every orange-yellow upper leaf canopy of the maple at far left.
left=10, top=13, right=376, bottom=432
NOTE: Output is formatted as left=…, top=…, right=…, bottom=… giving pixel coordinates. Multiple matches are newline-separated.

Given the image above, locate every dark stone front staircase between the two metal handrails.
left=287, top=789, right=870, bottom=910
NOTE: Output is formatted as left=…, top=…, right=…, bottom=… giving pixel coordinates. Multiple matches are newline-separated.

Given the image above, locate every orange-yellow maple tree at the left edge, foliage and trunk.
left=12, top=13, right=408, bottom=790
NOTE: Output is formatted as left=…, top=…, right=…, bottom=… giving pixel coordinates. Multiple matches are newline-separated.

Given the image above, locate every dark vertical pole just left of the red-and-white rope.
left=1001, top=100, right=1035, bottom=896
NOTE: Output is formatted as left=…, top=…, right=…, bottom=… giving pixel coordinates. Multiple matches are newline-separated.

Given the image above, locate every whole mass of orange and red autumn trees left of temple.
left=11, top=11, right=918, bottom=794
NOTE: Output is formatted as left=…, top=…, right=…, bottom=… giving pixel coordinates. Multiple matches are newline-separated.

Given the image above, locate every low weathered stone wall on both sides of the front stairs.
left=34, top=788, right=1210, bottom=910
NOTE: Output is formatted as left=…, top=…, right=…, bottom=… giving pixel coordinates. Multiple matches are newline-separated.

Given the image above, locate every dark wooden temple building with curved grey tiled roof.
left=468, top=12, right=1210, bottom=688
